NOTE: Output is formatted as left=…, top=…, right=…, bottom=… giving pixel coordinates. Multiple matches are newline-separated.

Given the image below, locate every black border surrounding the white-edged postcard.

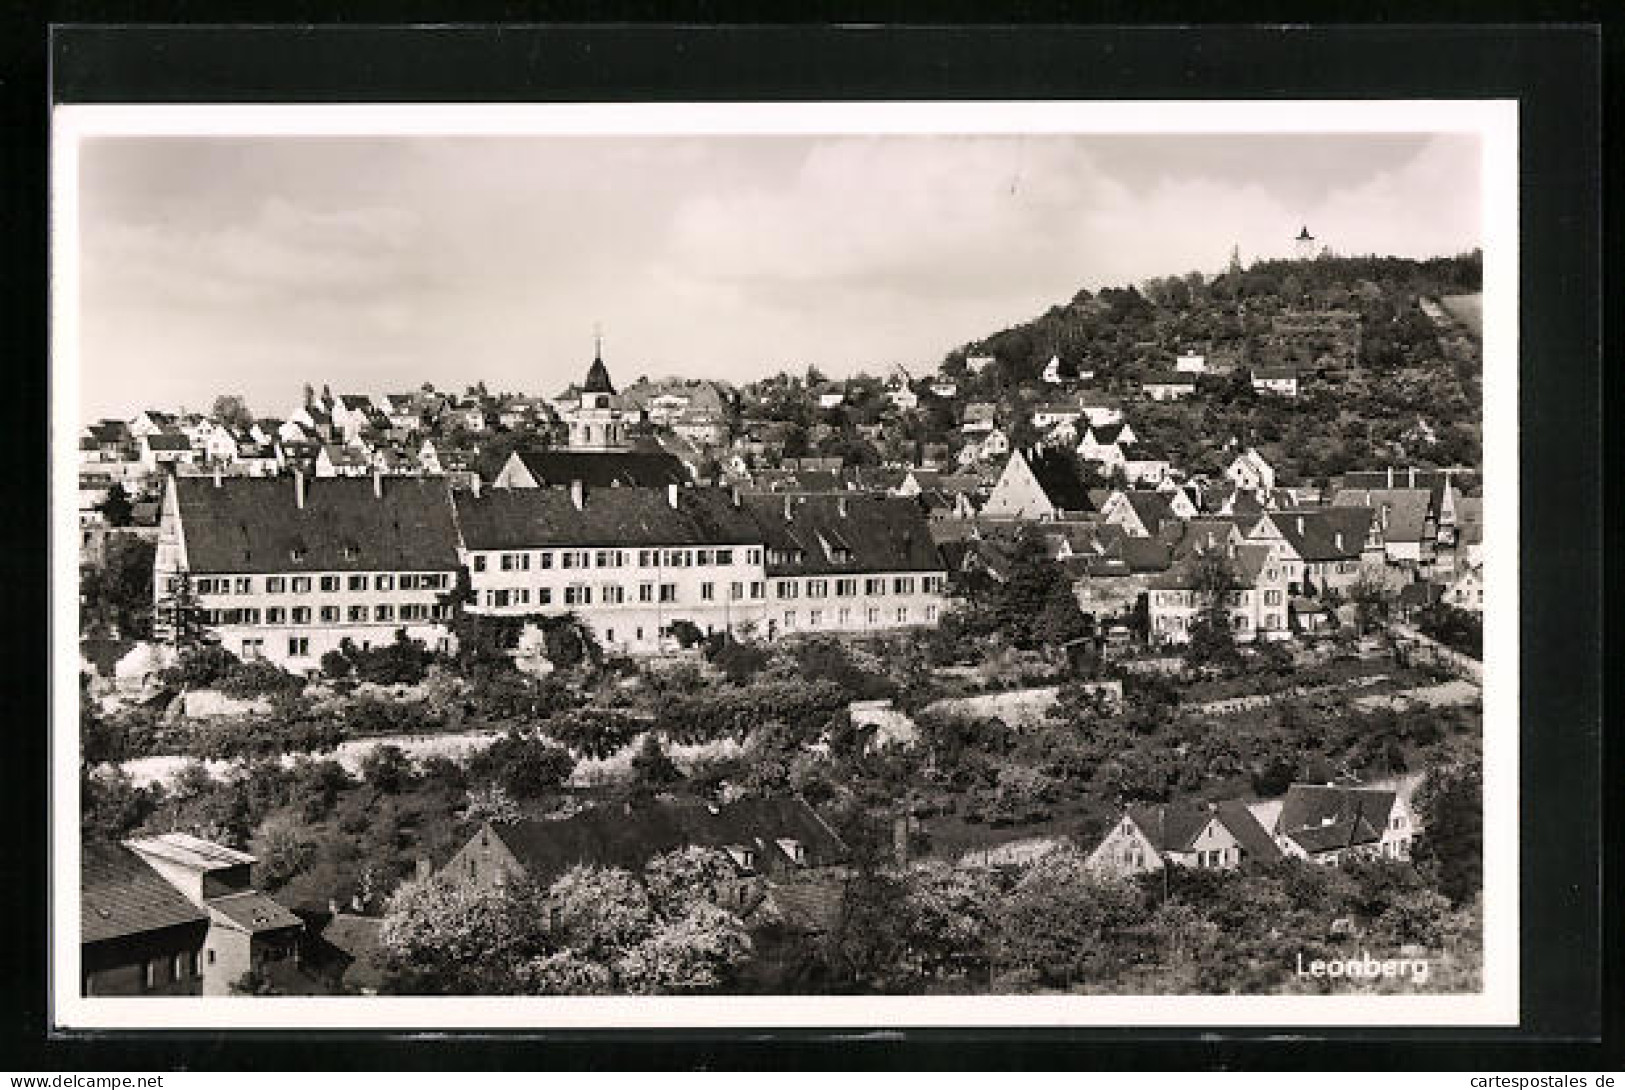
left=0, top=17, right=1625, bottom=1071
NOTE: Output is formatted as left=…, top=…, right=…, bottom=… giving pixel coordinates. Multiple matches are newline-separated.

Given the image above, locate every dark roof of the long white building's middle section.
left=455, top=487, right=761, bottom=549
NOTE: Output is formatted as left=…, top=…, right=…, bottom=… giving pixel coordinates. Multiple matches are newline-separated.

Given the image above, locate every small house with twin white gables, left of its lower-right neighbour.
left=1089, top=799, right=1282, bottom=876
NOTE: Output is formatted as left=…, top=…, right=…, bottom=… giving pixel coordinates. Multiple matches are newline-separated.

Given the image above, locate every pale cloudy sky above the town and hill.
left=80, top=135, right=1480, bottom=419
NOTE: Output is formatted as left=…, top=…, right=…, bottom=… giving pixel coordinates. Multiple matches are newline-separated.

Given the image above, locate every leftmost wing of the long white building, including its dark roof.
left=153, top=471, right=460, bottom=671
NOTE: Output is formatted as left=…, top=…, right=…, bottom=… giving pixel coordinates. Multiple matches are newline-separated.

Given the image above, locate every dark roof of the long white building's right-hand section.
left=744, top=492, right=944, bottom=575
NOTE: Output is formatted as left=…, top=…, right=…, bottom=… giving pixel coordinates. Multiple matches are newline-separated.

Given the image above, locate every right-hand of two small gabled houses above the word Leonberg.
left=1264, top=783, right=1420, bottom=866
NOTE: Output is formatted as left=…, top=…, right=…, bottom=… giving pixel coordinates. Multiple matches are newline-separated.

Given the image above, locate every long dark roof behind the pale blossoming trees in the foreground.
left=491, top=798, right=847, bottom=882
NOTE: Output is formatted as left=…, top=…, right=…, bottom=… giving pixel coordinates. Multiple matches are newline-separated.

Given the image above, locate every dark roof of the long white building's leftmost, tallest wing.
left=174, top=478, right=458, bottom=573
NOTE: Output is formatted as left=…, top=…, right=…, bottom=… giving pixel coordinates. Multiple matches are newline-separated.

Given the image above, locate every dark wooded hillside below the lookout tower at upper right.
left=943, top=252, right=1482, bottom=482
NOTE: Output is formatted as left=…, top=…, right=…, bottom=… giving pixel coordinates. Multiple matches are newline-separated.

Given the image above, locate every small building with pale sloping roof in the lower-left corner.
left=124, top=832, right=304, bottom=996
